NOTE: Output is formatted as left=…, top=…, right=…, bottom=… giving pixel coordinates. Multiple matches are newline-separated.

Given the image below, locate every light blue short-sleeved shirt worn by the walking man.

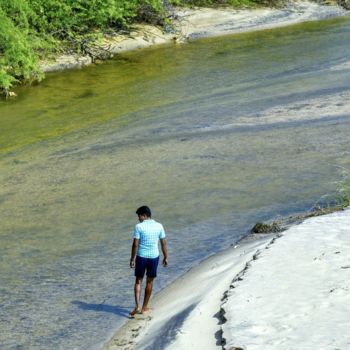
left=134, top=219, right=165, bottom=259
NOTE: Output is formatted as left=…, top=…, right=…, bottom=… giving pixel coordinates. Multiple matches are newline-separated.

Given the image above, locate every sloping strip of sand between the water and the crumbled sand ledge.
left=99, top=204, right=350, bottom=350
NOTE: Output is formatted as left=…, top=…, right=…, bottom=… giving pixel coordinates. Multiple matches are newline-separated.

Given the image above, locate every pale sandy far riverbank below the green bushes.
left=41, top=1, right=347, bottom=72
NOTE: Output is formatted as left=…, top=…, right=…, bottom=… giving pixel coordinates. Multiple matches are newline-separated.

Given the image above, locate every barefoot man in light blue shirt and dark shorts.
left=130, top=206, right=168, bottom=317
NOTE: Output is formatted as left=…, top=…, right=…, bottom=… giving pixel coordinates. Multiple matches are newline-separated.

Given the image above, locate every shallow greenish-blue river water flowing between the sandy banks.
left=0, top=18, right=350, bottom=349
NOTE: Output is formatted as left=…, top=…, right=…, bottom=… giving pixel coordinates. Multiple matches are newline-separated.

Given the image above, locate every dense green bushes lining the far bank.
left=0, top=0, right=274, bottom=94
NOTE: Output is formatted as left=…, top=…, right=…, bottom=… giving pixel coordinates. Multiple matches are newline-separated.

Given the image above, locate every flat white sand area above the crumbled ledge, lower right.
left=222, top=209, right=350, bottom=350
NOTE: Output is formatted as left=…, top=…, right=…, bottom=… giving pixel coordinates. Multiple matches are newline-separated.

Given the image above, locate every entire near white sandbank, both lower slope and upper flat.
left=103, top=208, right=350, bottom=350
